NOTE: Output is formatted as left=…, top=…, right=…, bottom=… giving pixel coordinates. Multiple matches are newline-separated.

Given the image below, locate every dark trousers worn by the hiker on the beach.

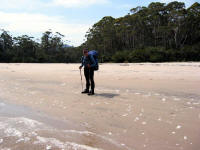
left=84, top=67, right=94, bottom=90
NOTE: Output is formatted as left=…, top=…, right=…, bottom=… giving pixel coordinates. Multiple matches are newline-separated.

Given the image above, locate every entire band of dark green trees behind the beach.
left=0, top=1, right=200, bottom=62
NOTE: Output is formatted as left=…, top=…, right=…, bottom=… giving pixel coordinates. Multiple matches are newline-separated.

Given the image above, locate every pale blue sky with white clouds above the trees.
left=0, top=0, right=198, bottom=46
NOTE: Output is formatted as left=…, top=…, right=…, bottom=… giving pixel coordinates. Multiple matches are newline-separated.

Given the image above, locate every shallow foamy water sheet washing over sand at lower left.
left=0, top=102, right=129, bottom=150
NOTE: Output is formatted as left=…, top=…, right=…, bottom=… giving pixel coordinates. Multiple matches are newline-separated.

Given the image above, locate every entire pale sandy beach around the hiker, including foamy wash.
left=0, top=63, right=200, bottom=150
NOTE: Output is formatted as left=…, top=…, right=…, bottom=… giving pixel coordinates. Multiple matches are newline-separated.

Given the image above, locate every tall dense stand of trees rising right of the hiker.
left=85, top=1, right=200, bottom=62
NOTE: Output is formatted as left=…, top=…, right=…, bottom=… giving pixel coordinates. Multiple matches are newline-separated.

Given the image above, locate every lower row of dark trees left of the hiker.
left=0, top=30, right=81, bottom=63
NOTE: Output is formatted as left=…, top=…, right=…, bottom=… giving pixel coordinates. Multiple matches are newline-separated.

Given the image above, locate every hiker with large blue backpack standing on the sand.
left=79, top=49, right=98, bottom=95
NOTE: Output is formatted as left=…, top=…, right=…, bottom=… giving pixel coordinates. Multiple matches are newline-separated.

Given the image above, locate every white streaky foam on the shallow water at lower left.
left=0, top=117, right=129, bottom=150
